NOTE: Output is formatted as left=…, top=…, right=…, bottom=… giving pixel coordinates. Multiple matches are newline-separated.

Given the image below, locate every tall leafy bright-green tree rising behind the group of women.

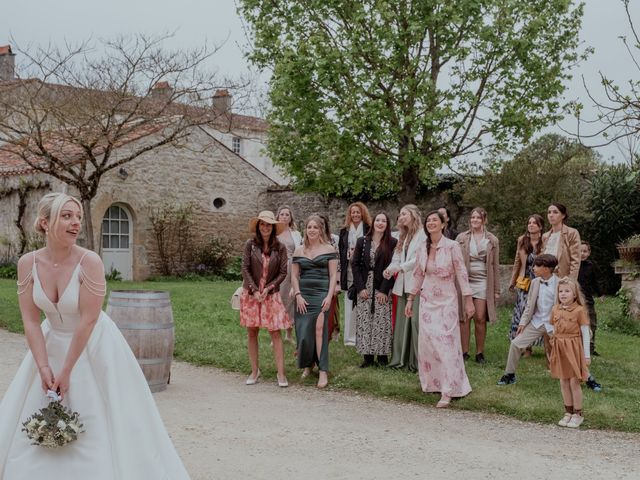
left=239, top=0, right=583, bottom=200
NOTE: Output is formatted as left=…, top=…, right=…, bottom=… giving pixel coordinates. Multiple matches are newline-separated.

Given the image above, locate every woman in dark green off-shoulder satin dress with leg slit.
left=291, top=215, right=338, bottom=388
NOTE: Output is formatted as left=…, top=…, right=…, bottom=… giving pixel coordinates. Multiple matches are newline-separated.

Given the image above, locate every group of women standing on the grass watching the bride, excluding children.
left=241, top=202, right=580, bottom=407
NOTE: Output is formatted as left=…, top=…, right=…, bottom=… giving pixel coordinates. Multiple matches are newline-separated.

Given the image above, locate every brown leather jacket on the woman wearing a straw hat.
left=242, top=239, right=288, bottom=294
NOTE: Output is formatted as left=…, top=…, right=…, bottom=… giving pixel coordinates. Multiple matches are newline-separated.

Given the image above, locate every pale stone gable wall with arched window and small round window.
left=93, top=127, right=274, bottom=279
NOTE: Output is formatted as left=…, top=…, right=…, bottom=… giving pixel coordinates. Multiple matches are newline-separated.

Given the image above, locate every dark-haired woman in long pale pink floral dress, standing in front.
left=405, top=210, right=475, bottom=408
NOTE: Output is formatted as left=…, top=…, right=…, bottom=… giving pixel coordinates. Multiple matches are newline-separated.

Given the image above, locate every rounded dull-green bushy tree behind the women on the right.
left=461, top=134, right=600, bottom=263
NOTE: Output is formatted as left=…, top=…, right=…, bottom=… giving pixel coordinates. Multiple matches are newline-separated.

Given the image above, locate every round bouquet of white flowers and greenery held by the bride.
left=22, top=390, right=84, bottom=448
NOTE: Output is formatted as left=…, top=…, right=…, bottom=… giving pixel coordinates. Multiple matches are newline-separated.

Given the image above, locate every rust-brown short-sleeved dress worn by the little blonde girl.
left=550, top=302, right=589, bottom=381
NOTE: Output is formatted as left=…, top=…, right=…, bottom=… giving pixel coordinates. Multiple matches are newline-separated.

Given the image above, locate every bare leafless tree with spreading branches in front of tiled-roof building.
left=0, top=34, right=241, bottom=248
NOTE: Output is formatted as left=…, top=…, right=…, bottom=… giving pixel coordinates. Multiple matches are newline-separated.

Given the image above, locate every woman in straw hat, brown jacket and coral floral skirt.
left=240, top=210, right=291, bottom=387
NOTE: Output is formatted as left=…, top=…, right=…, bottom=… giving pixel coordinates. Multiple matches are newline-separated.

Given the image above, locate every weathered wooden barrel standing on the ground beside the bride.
left=107, top=290, right=175, bottom=392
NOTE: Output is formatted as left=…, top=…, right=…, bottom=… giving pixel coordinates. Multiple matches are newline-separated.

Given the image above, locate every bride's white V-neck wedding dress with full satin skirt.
left=0, top=260, right=189, bottom=480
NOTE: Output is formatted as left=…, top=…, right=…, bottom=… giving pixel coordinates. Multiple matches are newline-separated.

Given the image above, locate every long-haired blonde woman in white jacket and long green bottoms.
left=384, top=204, right=426, bottom=372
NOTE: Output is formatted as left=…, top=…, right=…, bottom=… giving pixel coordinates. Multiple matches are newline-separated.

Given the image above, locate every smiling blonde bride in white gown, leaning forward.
left=0, top=193, right=189, bottom=480
